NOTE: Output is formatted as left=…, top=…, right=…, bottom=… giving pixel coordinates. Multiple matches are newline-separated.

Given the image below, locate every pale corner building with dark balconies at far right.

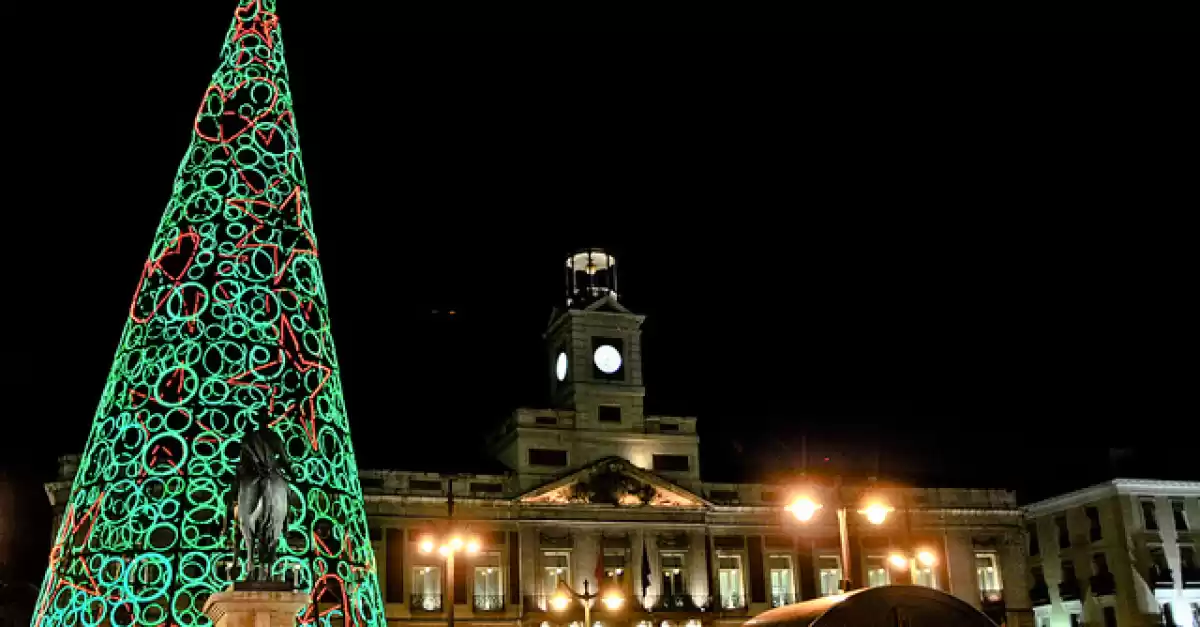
left=1026, top=479, right=1200, bottom=627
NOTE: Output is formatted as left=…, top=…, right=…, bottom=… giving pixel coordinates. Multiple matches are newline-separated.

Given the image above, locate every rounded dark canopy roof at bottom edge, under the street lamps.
left=745, top=586, right=996, bottom=627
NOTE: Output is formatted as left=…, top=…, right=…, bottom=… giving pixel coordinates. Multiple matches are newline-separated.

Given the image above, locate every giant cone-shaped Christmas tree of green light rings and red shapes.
left=34, top=0, right=384, bottom=627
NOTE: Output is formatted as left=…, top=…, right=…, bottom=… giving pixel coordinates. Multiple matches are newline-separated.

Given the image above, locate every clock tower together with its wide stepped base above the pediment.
left=490, top=249, right=700, bottom=489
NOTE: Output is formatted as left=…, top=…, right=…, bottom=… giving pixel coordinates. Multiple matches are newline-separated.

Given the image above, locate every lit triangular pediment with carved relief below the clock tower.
left=517, top=458, right=709, bottom=508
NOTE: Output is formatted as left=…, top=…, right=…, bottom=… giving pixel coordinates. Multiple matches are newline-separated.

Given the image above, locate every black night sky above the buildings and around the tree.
left=0, top=0, right=1200, bottom=595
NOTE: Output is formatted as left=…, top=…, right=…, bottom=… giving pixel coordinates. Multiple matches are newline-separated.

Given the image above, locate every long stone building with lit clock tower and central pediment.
left=47, top=250, right=1041, bottom=627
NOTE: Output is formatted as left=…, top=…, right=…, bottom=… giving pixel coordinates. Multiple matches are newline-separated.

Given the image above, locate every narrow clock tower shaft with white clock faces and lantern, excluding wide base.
left=545, top=249, right=646, bottom=430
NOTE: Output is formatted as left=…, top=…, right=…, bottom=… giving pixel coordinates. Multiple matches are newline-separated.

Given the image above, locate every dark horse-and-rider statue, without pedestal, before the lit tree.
left=234, top=425, right=294, bottom=581
